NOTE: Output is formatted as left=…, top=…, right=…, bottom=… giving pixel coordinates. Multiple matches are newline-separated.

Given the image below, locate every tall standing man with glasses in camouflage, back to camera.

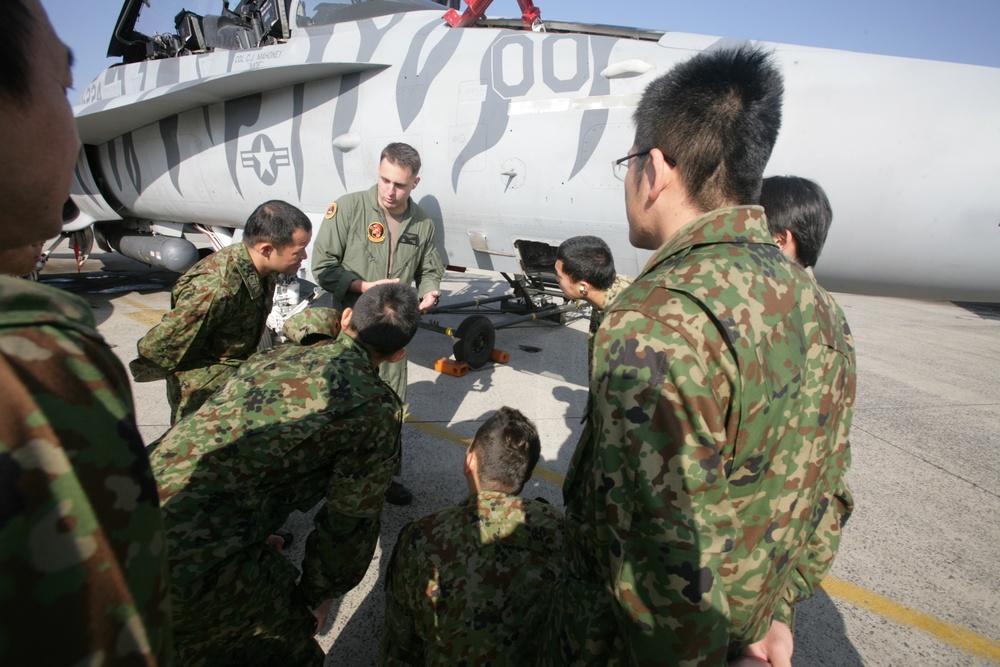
left=549, top=46, right=855, bottom=665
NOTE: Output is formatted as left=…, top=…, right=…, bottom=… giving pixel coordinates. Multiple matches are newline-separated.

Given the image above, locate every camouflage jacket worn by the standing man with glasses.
left=563, top=207, right=855, bottom=665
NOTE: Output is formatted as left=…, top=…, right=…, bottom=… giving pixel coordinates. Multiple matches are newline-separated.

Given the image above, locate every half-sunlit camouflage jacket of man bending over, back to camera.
left=150, top=333, right=401, bottom=604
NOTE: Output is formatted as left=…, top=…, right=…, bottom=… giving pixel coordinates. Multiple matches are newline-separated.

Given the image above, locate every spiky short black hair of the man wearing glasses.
left=633, top=44, right=784, bottom=212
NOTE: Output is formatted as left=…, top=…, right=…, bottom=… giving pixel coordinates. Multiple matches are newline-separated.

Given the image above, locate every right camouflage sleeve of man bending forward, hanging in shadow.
left=299, top=408, right=400, bottom=606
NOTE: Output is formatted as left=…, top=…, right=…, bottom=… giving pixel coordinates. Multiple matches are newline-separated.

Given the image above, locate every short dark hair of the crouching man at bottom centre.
left=469, top=406, right=542, bottom=494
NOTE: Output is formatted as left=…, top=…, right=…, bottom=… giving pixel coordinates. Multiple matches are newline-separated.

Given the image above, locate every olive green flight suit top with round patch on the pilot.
left=312, top=185, right=444, bottom=311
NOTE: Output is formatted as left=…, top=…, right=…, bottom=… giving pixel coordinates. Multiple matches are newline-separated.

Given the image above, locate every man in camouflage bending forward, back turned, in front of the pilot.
left=151, top=285, right=420, bottom=667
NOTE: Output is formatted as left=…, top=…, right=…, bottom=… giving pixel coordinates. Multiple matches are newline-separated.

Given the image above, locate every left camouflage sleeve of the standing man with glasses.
left=593, top=306, right=738, bottom=665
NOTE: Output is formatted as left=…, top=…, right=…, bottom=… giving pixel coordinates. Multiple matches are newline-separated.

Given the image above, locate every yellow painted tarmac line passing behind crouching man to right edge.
left=407, top=415, right=1000, bottom=664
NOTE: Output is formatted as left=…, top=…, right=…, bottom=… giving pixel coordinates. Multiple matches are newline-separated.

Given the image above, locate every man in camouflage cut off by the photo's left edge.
left=0, top=0, right=173, bottom=667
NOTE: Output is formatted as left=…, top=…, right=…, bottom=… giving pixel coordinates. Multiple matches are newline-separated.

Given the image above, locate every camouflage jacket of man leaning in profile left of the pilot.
left=130, top=243, right=276, bottom=422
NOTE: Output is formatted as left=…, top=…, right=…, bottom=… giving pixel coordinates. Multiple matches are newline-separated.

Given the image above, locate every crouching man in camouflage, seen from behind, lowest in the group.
left=378, top=407, right=562, bottom=667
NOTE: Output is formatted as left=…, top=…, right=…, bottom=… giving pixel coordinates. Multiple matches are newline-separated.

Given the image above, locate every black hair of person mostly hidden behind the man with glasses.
left=760, top=176, right=833, bottom=268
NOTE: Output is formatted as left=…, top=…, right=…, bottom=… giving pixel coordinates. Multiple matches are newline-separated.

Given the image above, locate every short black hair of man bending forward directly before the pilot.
left=348, top=283, right=420, bottom=357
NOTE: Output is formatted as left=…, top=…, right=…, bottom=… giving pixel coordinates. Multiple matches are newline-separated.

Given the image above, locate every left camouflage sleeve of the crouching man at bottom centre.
left=378, top=523, right=424, bottom=667
